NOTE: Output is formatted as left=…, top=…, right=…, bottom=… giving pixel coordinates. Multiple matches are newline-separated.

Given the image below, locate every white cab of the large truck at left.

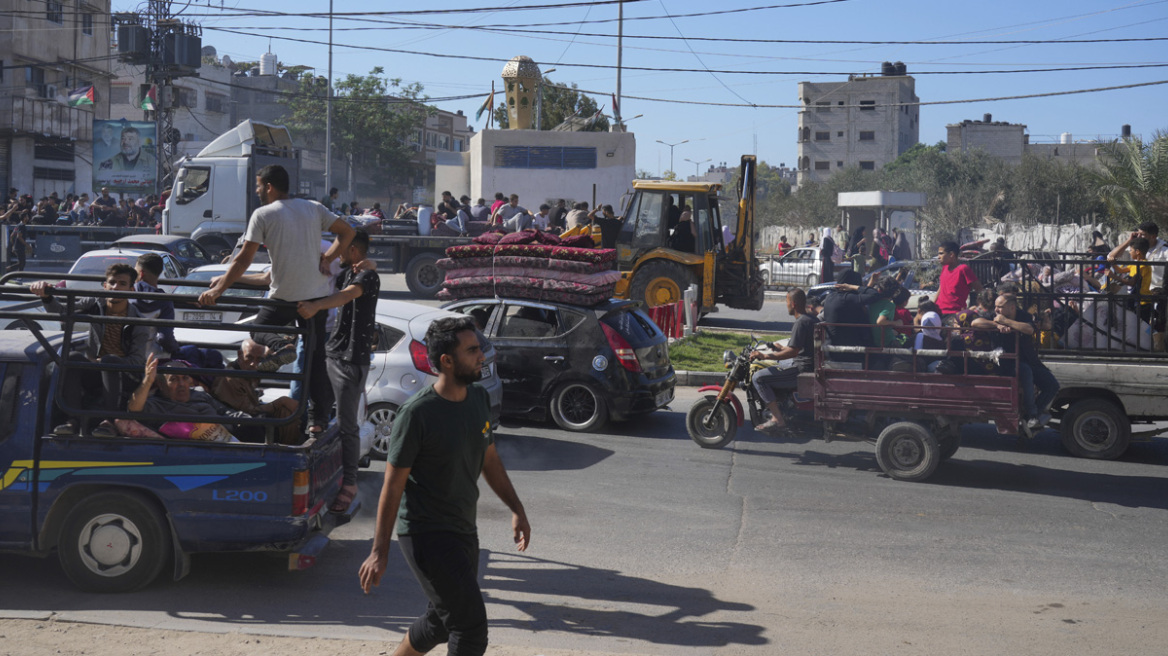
left=162, top=119, right=300, bottom=253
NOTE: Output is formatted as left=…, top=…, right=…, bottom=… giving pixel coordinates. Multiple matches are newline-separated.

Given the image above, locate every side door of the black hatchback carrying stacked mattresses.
left=491, top=301, right=569, bottom=414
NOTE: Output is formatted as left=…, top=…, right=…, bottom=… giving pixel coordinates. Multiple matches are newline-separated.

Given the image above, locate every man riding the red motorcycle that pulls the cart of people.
left=750, top=287, right=819, bottom=437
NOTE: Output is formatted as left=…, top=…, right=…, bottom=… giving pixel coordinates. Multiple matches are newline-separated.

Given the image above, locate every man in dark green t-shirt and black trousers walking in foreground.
left=360, top=316, right=531, bottom=656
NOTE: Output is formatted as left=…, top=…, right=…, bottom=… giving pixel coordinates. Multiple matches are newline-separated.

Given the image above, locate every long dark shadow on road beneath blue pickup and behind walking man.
left=0, top=540, right=766, bottom=647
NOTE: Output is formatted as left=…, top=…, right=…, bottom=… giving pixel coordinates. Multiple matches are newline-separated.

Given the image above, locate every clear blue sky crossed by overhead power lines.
left=113, top=0, right=1168, bottom=175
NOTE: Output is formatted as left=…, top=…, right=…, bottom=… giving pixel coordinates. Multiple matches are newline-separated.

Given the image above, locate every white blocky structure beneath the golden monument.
left=436, top=130, right=637, bottom=212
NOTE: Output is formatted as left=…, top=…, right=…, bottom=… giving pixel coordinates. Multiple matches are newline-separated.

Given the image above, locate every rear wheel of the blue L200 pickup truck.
left=57, top=491, right=173, bottom=592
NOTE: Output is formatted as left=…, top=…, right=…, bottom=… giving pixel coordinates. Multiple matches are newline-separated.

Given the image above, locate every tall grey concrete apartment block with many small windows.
left=797, top=62, right=920, bottom=184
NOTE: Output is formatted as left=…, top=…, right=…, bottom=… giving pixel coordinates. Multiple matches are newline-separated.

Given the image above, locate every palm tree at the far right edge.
left=1098, top=131, right=1168, bottom=224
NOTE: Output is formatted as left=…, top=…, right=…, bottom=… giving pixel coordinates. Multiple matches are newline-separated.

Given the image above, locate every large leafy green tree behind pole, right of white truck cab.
left=285, top=67, right=434, bottom=188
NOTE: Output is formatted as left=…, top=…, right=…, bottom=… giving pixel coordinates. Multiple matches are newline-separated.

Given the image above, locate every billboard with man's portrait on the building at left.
left=93, top=119, right=158, bottom=195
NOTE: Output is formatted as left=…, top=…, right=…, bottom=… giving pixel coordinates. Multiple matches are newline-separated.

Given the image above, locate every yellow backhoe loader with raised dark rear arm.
left=616, top=155, right=763, bottom=313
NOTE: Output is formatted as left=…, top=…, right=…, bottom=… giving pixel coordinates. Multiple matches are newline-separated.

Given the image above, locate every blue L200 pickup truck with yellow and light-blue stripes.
left=0, top=294, right=360, bottom=592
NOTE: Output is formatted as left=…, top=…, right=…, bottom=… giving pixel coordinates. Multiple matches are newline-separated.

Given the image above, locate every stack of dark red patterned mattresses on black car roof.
left=438, top=231, right=620, bottom=307
